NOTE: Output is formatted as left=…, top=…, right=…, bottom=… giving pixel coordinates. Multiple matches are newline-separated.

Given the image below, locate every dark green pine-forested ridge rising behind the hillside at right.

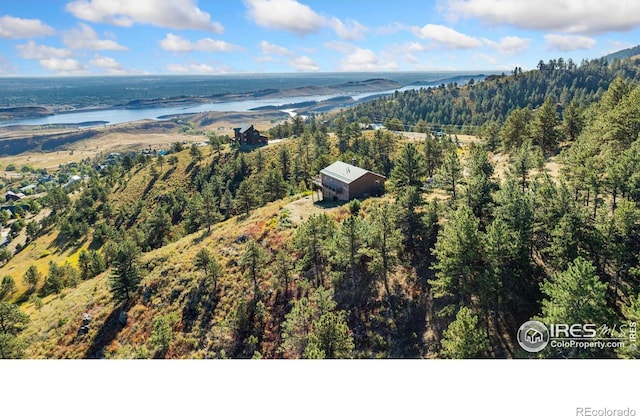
left=342, top=58, right=640, bottom=133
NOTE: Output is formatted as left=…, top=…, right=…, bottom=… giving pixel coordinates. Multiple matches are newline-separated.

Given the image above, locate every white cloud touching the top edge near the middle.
left=245, top=0, right=368, bottom=40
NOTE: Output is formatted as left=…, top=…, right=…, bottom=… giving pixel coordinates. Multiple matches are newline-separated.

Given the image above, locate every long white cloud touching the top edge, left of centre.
left=66, top=0, right=224, bottom=33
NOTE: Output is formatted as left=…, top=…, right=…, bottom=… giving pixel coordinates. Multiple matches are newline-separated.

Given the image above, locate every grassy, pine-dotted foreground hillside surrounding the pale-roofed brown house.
left=0, top=54, right=640, bottom=358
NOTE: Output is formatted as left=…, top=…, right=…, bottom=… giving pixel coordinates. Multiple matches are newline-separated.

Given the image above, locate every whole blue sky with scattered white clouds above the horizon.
left=0, top=0, right=640, bottom=76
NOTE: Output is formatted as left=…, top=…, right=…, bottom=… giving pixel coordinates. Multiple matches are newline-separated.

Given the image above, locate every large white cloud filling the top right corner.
left=442, top=0, right=640, bottom=34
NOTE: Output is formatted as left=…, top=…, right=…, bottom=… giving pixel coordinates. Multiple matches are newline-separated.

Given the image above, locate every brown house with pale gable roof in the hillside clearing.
left=316, top=161, right=387, bottom=201
